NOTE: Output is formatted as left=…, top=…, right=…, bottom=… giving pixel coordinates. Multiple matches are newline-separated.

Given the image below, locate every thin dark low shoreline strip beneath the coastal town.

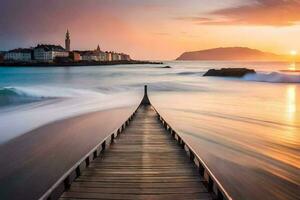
left=0, top=60, right=164, bottom=67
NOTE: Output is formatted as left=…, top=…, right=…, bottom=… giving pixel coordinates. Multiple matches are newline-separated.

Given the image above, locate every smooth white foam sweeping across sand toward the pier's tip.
left=0, top=87, right=141, bottom=143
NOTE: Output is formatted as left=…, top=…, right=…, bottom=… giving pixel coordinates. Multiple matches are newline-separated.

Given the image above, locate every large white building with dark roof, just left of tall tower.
left=34, top=45, right=69, bottom=62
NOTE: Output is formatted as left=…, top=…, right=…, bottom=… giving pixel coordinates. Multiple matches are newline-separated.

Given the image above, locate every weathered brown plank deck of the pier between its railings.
left=61, top=106, right=212, bottom=200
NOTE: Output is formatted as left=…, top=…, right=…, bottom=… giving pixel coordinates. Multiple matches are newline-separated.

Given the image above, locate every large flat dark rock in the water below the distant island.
left=203, top=68, right=256, bottom=78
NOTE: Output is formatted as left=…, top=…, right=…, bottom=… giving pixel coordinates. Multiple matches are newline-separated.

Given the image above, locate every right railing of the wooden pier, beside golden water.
left=153, top=107, right=232, bottom=200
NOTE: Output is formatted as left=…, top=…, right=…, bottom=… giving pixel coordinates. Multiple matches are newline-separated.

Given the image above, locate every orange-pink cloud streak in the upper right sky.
left=179, top=0, right=300, bottom=26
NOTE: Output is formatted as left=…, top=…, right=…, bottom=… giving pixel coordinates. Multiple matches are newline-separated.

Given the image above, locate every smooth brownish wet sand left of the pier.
left=0, top=107, right=135, bottom=200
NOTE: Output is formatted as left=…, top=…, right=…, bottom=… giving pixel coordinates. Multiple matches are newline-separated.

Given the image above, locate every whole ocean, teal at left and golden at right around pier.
left=0, top=61, right=300, bottom=200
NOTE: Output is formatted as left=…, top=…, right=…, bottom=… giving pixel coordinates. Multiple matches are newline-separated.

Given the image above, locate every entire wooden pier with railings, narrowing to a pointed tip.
left=41, top=85, right=231, bottom=200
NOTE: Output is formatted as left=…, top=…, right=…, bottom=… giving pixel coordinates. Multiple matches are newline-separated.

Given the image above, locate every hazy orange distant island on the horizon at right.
left=176, top=47, right=288, bottom=61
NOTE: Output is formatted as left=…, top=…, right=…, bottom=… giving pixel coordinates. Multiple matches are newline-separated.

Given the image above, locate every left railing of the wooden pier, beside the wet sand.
left=39, top=107, right=139, bottom=200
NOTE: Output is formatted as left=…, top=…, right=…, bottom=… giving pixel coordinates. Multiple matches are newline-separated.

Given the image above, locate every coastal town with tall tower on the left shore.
left=0, top=30, right=131, bottom=65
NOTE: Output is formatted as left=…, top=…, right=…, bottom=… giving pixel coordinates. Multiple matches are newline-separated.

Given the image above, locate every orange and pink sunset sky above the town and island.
left=0, top=0, right=300, bottom=60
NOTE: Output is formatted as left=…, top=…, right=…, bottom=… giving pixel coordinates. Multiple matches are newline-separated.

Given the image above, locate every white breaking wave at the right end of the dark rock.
left=243, top=72, right=300, bottom=83
